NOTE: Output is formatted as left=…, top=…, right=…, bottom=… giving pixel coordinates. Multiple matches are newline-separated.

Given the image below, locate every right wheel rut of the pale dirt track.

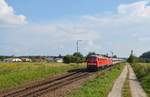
left=128, top=65, right=147, bottom=97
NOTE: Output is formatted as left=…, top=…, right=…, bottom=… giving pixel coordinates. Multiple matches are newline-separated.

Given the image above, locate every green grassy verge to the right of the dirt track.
left=132, top=63, right=150, bottom=97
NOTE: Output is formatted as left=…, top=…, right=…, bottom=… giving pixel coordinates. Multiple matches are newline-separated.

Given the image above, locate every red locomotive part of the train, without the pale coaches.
left=87, top=55, right=113, bottom=70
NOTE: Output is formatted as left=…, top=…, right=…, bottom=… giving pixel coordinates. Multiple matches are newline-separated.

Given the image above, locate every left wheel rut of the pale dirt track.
left=108, top=65, right=127, bottom=97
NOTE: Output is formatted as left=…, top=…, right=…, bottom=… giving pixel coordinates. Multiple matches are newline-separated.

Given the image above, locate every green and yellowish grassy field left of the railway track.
left=0, top=63, right=85, bottom=91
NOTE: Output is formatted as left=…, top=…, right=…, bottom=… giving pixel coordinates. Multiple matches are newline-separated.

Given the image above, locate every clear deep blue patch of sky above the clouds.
left=6, top=0, right=141, bottom=22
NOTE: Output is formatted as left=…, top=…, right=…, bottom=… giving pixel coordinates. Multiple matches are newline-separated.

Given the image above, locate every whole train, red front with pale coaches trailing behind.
left=87, top=55, right=124, bottom=71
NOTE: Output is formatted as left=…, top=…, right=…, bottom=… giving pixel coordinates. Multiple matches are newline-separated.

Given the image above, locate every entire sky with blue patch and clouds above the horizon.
left=0, top=0, right=150, bottom=57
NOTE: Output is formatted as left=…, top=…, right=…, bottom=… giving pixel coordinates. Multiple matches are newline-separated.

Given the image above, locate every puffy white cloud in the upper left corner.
left=0, top=0, right=27, bottom=26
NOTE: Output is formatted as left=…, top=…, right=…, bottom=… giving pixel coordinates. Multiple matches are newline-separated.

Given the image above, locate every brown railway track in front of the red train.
left=0, top=71, right=92, bottom=97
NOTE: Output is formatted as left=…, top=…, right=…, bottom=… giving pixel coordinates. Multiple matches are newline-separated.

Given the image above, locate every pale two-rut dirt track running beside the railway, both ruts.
left=108, top=64, right=147, bottom=97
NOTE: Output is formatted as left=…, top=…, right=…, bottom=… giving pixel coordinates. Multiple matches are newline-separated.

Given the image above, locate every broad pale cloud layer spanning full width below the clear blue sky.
left=0, top=1, right=150, bottom=56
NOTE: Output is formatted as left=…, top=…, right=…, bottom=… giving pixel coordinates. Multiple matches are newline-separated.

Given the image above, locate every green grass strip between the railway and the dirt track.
left=67, top=64, right=124, bottom=97
